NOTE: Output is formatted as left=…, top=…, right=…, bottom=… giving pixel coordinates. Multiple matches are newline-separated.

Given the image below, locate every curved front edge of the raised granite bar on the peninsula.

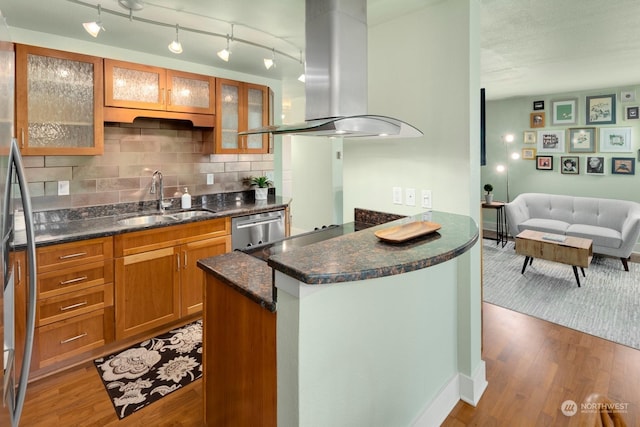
left=269, top=234, right=479, bottom=285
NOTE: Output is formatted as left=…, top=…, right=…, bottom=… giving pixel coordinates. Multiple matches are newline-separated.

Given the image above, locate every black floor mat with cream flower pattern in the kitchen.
left=94, top=320, right=202, bottom=419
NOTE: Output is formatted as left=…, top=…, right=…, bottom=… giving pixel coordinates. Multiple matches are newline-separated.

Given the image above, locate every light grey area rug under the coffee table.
left=483, top=240, right=640, bottom=350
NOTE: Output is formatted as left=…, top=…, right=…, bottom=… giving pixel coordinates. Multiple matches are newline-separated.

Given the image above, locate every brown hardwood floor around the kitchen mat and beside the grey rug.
left=20, top=303, right=640, bottom=427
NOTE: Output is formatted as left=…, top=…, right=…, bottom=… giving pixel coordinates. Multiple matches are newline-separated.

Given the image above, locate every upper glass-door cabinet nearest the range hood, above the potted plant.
left=215, top=79, right=269, bottom=154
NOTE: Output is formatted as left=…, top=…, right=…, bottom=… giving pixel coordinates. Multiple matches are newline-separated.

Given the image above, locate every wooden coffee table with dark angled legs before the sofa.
left=516, top=230, right=593, bottom=287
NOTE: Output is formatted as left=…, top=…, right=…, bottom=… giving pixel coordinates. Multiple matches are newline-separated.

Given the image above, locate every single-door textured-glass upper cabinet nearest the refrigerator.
left=16, top=44, right=104, bottom=155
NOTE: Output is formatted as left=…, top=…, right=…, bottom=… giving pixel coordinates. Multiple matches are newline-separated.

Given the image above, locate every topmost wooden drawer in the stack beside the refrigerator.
left=36, top=237, right=113, bottom=273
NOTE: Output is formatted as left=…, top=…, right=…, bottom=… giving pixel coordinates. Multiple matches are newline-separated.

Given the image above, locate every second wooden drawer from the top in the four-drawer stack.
left=38, top=260, right=113, bottom=299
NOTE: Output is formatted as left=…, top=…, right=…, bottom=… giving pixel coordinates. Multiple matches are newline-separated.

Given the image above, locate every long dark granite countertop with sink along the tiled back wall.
left=14, top=194, right=289, bottom=248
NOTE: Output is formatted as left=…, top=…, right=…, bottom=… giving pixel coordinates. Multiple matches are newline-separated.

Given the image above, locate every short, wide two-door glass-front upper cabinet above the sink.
left=104, top=59, right=215, bottom=121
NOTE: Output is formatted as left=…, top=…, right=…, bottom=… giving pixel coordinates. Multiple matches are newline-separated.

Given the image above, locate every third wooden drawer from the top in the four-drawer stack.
left=37, top=283, right=113, bottom=326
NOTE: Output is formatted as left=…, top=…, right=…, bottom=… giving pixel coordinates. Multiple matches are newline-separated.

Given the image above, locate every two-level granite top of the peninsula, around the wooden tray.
left=198, top=212, right=479, bottom=311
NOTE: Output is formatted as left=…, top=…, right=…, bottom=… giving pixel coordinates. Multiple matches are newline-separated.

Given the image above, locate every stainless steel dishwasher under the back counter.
left=231, top=209, right=285, bottom=250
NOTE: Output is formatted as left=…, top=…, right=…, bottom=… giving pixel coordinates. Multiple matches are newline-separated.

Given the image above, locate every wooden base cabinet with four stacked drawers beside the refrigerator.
left=32, top=237, right=114, bottom=369
